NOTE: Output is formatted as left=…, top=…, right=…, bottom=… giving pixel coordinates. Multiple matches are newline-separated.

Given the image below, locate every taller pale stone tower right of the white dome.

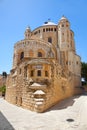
left=58, top=16, right=75, bottom=51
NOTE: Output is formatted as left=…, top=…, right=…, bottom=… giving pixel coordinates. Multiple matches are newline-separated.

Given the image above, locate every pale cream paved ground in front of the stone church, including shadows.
left=0, top=95, right=87, bottom=130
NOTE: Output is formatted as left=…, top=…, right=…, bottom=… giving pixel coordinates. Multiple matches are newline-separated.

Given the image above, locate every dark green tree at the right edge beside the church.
left=81, top=62, right=87, bottom=85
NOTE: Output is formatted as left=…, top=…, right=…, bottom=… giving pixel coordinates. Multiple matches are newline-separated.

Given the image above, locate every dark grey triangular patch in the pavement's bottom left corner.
left=0, top=112, right=15, bottom=130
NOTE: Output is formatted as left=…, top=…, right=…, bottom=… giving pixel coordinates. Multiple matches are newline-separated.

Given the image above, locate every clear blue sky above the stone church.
left=0, top=0, right=87, bottom=73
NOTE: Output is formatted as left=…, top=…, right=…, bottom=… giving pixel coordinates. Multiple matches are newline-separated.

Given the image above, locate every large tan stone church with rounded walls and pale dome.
left=5, top=16, right=81, bottom=112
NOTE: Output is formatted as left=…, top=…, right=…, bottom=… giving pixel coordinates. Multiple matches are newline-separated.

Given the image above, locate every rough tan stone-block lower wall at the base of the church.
left=6, top=63, right=81, bottom=112
